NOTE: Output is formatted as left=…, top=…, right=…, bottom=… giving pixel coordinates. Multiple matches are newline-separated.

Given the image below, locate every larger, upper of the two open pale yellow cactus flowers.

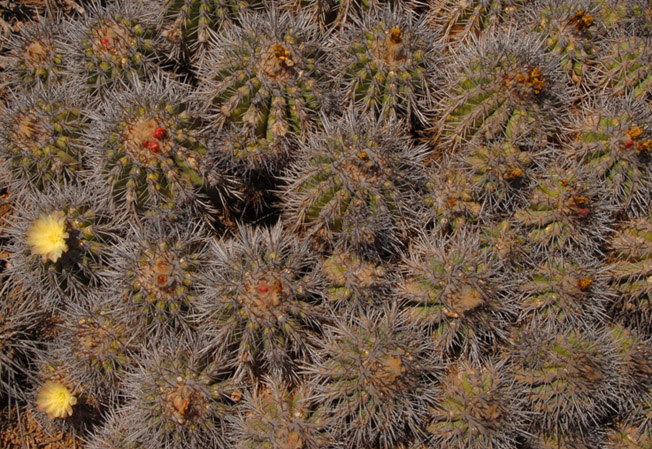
left=27, top=211, right=68, bottom=262
